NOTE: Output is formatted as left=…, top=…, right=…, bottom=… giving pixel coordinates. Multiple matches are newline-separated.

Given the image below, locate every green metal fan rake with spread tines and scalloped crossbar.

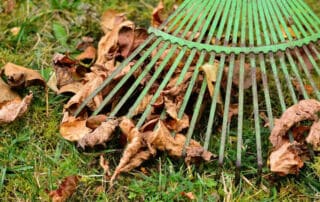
left=75, top=0, right=320, bottom=180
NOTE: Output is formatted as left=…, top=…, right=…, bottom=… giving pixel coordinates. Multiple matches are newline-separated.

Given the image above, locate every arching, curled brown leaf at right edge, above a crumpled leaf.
left=269, top=99, right=320, bottom=148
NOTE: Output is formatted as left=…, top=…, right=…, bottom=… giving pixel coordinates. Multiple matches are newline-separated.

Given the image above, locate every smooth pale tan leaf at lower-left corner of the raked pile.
left=60, top=112, right=92, bottom=141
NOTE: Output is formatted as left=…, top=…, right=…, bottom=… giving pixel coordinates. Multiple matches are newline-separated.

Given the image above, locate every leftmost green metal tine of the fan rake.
left=74, top=0, right=193, bottom=116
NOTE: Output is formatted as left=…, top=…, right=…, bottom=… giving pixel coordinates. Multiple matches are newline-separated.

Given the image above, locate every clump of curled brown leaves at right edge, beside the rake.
left=269, top=99, right=320, bottom=176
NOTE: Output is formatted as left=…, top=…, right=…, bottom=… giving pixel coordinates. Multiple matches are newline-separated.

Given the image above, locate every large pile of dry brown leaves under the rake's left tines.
left=48, top=4, right=212, bottom=188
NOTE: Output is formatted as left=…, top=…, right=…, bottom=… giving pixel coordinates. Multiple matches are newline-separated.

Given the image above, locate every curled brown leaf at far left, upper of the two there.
left=3, top=63, right=46, bottom=87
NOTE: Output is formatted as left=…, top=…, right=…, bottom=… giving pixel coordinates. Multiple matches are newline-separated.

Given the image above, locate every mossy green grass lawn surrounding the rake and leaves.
left=0, top=0, right=320, bottom=201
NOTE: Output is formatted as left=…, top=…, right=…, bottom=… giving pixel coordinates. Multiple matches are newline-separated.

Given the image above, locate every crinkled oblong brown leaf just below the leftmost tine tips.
left=78, top=119, right=119, bottom=148
